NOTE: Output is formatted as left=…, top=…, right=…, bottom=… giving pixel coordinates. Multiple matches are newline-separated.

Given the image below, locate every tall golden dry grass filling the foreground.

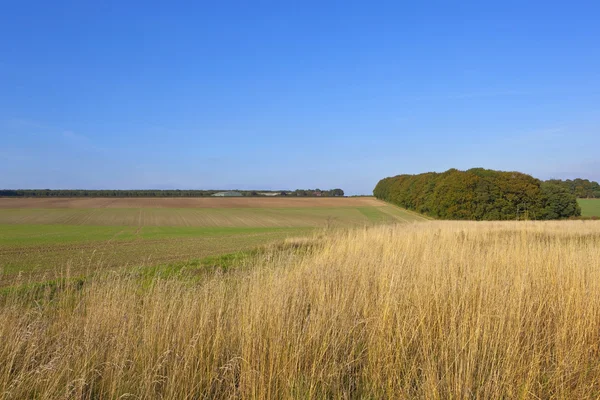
left=0, top=221, right=600, bottom=399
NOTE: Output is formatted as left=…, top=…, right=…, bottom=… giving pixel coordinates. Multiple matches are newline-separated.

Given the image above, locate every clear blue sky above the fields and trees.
left=0, top=1, right=600, bottom=194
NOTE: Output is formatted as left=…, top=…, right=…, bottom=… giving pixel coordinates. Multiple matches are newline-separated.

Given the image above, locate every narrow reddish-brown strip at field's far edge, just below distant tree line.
left=0, top=197, right=385, bottom=208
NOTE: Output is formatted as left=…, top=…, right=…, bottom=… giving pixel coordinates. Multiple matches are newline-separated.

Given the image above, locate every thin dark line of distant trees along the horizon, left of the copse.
left=0, top=189, right=344, bottom=197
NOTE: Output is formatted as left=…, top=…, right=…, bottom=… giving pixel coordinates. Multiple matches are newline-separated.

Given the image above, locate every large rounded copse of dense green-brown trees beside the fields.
left=373, top=168, right=581, bottom=220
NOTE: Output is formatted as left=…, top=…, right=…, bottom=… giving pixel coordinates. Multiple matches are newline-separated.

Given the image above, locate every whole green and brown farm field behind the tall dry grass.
left=0, top=198, right=424, bottom=286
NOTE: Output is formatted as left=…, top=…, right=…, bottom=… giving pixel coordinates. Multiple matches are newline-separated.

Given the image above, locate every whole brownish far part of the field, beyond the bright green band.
left=0, top=197, right=425, bottom=228
